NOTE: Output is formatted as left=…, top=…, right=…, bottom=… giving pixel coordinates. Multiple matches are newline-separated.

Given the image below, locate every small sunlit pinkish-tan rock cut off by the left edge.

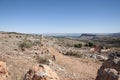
left=0, top=61, right=8, bottom=80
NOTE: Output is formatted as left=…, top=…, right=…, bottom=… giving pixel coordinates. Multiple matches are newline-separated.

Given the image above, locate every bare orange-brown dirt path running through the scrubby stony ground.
left=48, top=47, right=101, bottom=80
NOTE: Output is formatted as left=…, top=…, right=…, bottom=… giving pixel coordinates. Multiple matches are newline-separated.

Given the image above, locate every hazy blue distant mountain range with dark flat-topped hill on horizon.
left=43, top=33, right=120, bottom=39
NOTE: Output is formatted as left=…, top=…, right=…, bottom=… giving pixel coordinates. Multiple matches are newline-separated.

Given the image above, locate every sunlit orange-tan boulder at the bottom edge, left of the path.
left=24, top=64, right=60, bottom=80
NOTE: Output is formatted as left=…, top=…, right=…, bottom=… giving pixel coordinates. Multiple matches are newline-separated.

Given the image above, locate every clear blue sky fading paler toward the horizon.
left=0, top=0, right=120, bottom=33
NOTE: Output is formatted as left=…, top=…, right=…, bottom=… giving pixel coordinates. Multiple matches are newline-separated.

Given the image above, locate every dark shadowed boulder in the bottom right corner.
left=96, top=52, right=120, bottom=80
